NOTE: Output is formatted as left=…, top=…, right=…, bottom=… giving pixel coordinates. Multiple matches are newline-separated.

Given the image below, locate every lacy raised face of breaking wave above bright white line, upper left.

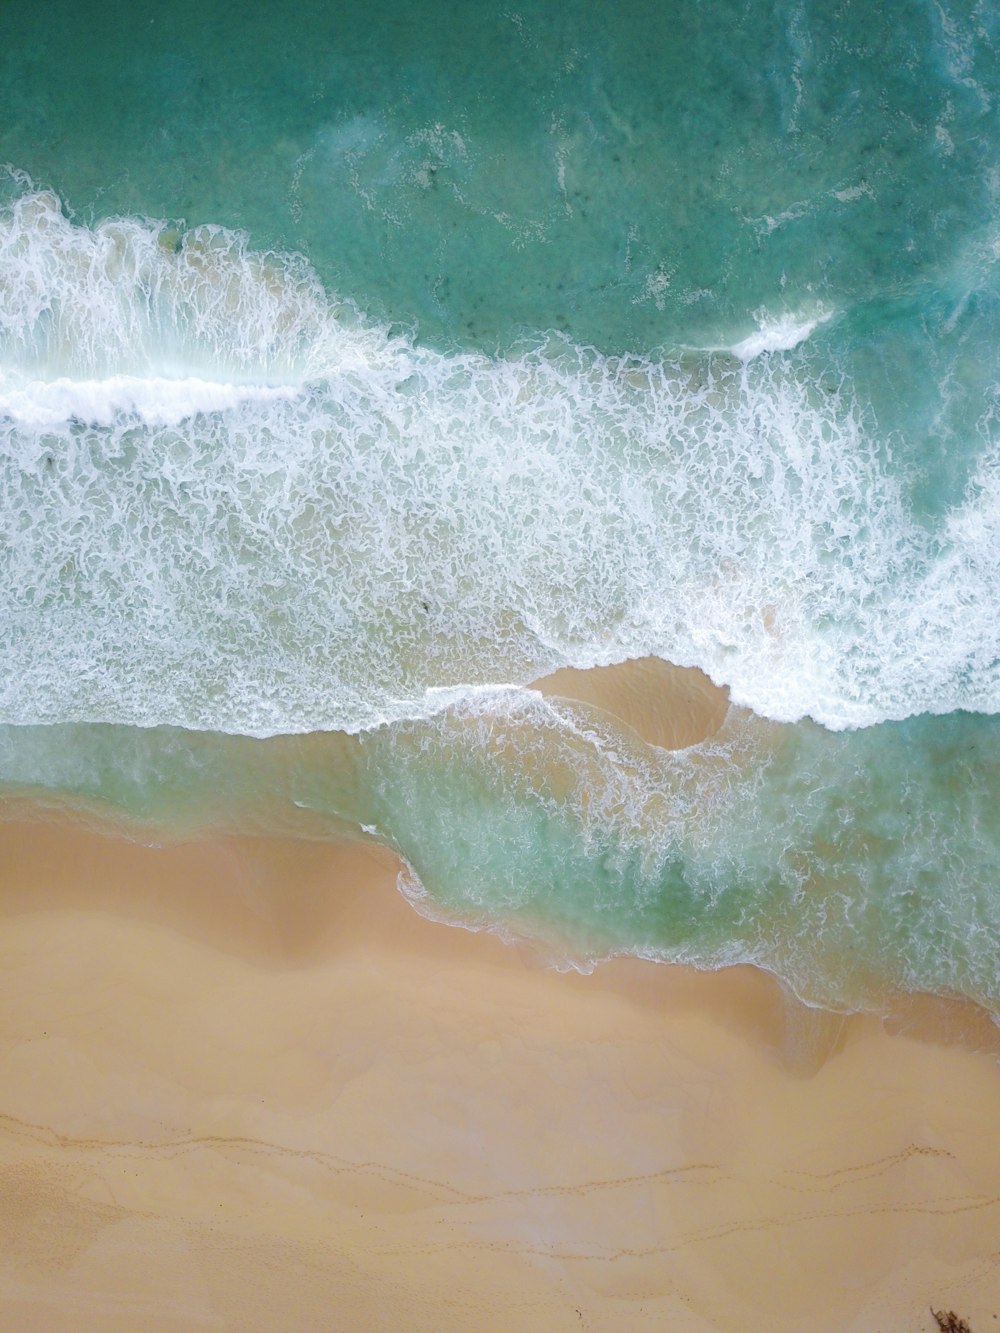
left=0, top=177, right=384, bottom=384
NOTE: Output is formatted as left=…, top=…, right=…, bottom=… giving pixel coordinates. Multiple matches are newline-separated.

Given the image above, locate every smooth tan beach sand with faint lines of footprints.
left=0, top=810, right=1000, bottom=1333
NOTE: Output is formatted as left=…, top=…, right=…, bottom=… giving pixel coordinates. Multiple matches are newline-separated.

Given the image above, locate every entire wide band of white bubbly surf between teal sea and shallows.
left=0, top=185, right=1000, bottom=734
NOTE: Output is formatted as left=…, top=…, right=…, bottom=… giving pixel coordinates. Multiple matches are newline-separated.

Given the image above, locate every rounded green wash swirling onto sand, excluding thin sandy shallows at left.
left=364, top=709, right=1000, bottom=1008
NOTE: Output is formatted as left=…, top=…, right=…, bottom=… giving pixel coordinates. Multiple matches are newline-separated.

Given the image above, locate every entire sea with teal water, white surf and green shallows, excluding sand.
left=0, top=0, right=1000, bottom=1009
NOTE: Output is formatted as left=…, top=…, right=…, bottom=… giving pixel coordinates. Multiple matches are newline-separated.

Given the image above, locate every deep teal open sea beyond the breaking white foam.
left=0, top=0, right=1000, bottom=351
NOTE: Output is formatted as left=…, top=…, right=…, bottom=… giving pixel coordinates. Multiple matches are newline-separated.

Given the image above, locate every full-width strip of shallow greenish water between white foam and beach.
left=0, top=690, right=1000, bottom=1012
